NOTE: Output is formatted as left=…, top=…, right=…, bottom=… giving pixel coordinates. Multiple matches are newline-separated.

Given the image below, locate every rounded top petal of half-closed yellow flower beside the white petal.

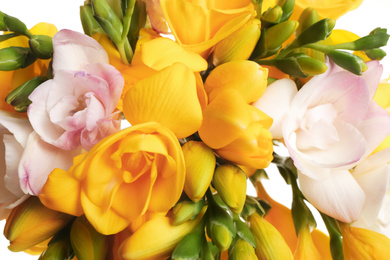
left=204, top=60, right=268, bottom=103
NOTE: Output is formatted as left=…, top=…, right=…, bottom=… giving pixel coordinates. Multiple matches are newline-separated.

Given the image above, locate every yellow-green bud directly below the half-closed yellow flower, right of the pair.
left=213, top=164, right=246, bottom=213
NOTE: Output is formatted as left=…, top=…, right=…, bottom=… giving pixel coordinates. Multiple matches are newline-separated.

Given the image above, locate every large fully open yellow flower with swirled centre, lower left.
left=39, top=122, right=185, bottom=235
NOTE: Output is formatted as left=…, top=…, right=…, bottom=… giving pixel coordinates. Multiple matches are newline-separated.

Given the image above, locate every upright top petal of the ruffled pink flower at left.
left=53, top=30, right=109, bottom=74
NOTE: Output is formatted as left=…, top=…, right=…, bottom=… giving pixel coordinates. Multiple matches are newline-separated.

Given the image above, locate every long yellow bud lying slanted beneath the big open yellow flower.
left=119, top=208, right=205, bottom=260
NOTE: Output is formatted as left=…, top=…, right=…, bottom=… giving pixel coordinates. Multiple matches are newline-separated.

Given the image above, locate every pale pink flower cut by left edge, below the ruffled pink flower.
left=0, top=110, right=80, bottom=219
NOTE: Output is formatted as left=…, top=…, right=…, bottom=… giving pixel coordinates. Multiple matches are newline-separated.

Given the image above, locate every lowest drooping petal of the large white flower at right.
left=298, top=170, right=365, bottom=223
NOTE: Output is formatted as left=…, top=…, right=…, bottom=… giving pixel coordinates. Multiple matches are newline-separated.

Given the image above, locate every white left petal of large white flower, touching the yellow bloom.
left=253, top=79, right=298, bottom=139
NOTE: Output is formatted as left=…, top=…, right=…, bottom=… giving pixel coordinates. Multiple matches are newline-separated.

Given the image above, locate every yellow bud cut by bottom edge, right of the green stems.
left=248, top=213, right=293, bottom=260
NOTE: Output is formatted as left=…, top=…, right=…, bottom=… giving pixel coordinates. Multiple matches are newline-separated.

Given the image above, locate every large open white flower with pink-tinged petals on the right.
left=255, top=61, right=390, bottom=222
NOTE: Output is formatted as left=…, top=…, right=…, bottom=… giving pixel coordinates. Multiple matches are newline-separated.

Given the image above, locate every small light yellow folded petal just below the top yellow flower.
left=141, top=38, right=208, bottom=71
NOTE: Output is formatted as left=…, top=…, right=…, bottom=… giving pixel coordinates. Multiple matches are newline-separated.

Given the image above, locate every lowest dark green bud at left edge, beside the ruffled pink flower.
left=5, top=77, right=46, bottom=112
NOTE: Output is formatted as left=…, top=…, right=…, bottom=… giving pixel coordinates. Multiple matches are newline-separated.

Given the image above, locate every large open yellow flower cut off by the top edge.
left=160, top=0, right=256, bottom=57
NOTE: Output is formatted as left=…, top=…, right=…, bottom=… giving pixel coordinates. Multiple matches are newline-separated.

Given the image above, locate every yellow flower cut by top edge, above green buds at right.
left=291, top=0, right=363, bottom=20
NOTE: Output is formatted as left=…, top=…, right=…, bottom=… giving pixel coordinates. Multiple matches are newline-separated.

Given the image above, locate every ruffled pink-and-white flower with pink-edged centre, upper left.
left=28, top=30, right=124, bottom=150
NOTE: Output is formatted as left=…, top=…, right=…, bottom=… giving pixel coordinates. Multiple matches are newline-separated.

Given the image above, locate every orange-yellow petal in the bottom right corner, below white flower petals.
left=340, top=223, right=390, bottom=260
